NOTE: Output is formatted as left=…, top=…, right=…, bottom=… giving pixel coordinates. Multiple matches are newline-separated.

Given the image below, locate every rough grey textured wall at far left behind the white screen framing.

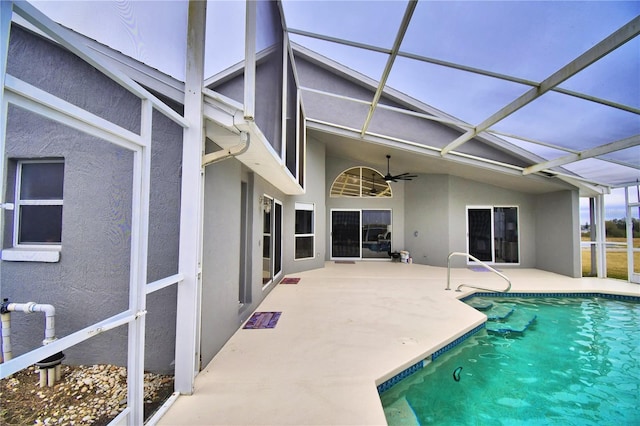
left=0, top=27, right=182, bottom=372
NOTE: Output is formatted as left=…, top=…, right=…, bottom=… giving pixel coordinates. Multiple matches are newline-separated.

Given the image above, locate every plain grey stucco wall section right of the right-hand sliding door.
left=535, top=191, right=582, bottom=278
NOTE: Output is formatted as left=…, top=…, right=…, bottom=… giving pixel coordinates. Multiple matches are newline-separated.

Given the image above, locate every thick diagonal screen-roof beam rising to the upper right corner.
left=441, top=16, right=640, bottom=156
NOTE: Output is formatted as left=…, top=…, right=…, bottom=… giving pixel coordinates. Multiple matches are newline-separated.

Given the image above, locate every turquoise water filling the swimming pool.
left=381, top=297, right=640, bottom=426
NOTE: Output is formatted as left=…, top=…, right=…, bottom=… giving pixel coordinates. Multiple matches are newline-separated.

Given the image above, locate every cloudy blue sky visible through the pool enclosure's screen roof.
left=25, top=0, right=640, bottom=216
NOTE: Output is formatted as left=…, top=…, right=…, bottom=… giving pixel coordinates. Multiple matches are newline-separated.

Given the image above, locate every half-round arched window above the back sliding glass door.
left=330, top=167, right=392, bottom=198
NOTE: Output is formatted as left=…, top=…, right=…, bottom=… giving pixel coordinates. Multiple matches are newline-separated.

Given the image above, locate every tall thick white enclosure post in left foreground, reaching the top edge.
left=175, top=0, right=207, bottom=394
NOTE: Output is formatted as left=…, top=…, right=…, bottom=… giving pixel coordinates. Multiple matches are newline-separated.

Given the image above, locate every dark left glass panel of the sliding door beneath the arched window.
left=331, top=210, right=361, bottom=258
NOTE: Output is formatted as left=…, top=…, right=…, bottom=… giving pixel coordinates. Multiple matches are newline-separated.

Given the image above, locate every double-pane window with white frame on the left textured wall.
left=13, top=160, right=64, bottom=246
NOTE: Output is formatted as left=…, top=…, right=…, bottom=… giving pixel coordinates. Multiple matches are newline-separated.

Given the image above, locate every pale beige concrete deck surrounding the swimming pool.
left=158, top=262, right=640, bottom=425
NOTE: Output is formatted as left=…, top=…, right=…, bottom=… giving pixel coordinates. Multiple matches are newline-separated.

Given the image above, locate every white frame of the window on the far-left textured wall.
left=12, top=159, right=64, bottom=250
